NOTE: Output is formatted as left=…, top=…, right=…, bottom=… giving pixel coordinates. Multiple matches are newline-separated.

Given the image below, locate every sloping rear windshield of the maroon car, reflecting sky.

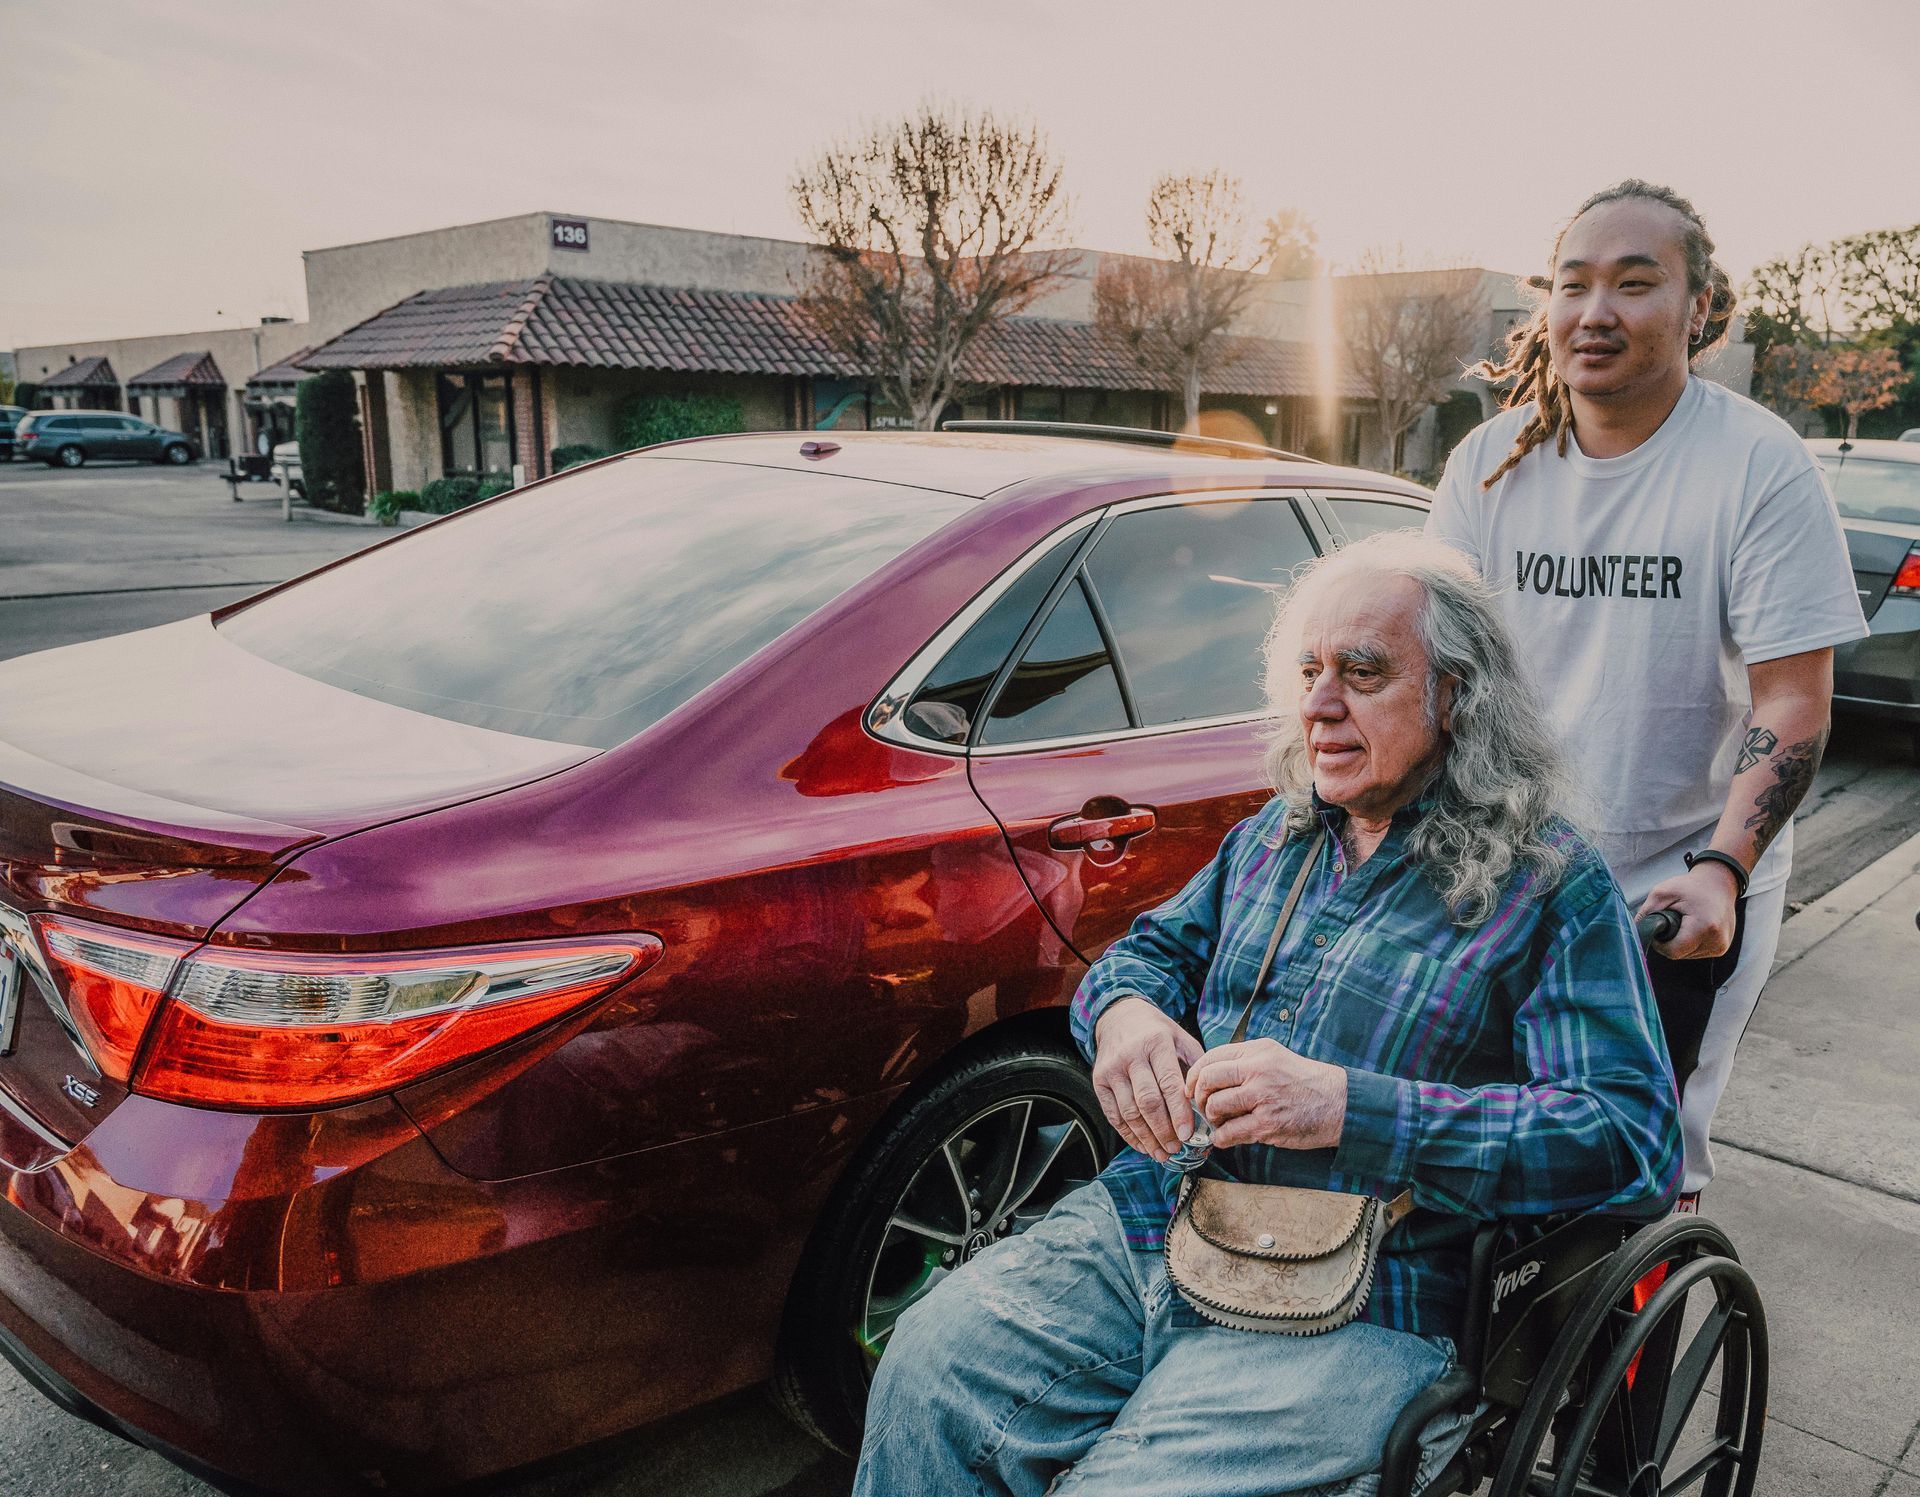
left=219, top=459, right=973, bottom=749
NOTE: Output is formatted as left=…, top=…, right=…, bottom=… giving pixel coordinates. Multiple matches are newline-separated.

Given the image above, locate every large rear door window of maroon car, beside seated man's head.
left=1087, top=499, right=1315, bottom=725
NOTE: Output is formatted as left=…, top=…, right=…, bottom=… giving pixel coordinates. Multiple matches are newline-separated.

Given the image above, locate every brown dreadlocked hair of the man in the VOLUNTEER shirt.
left=1469, top=177, right=1734, bottom=489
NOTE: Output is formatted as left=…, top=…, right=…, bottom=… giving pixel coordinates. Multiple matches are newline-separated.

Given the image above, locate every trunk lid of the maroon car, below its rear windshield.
left=0, top=618, right=593, bottom=1143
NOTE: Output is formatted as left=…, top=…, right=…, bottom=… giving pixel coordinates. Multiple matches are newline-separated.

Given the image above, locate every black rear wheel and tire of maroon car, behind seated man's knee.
left=772, top=1034, right=1116, bottom=1455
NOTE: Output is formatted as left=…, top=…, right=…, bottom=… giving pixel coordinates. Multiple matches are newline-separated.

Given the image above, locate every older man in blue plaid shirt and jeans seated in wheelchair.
left=856, top=534, right=1764, bottom=1497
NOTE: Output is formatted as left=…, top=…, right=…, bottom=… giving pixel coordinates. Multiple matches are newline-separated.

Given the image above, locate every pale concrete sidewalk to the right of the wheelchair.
left=1703, top=837, right=1920, bottom=1497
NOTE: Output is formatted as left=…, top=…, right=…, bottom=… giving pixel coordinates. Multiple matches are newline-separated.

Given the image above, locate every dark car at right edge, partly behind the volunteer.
left=1807, top=438, right=1920, bottom=752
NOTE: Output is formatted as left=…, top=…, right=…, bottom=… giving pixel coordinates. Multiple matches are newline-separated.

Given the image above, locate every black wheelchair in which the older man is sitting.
left=1380, top=912, right=1766, bottom=1497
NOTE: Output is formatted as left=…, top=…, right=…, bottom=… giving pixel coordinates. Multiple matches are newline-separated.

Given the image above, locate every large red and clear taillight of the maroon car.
left=132, top=935, right=662, bottom=1107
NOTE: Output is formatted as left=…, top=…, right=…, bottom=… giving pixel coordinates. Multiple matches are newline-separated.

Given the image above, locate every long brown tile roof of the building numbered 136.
left=300, top=276, right=1361, bottom=395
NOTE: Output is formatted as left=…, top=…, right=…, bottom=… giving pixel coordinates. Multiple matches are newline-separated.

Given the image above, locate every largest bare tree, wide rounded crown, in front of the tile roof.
left=791, top=104, right=1071, bottom=430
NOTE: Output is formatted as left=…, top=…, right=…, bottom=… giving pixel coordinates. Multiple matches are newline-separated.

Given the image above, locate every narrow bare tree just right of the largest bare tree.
left=1092, top=171, right=1265, bottom=428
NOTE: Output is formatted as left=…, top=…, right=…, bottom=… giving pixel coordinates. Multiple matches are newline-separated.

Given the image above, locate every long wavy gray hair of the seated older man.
left=1267, top=532, right=1571, bottom=925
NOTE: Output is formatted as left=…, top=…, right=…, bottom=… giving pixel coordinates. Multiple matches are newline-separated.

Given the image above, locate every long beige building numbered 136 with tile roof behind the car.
left=15, top=213, right=1751, bottom=491
